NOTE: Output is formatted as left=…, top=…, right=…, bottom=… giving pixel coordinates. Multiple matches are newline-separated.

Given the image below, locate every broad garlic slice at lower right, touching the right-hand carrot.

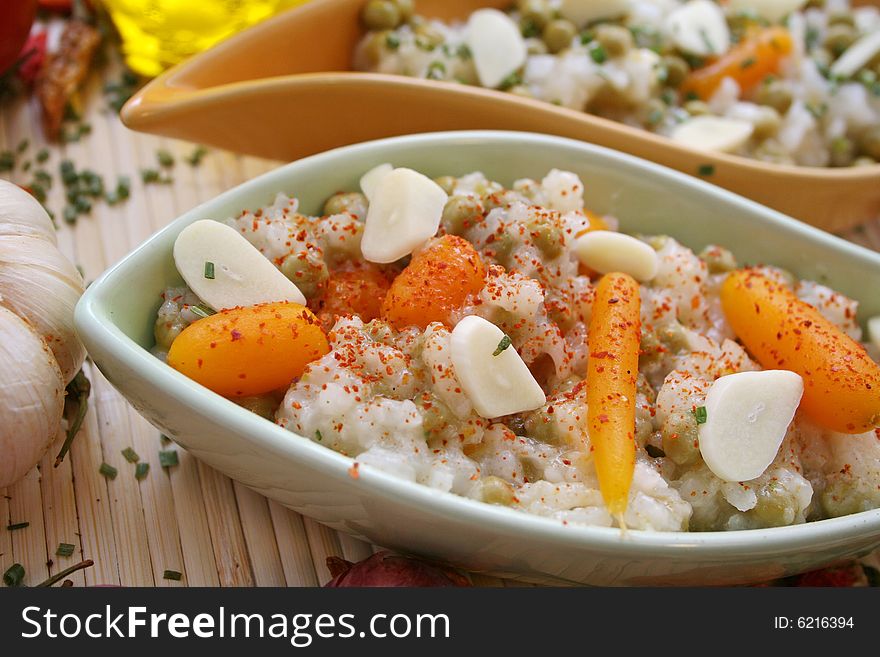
left=699, top=370, right=804, bottom=481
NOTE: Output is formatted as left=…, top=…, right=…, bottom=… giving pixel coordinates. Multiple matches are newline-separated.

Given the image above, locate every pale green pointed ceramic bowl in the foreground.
left=76, top=131, right=880, bottom=585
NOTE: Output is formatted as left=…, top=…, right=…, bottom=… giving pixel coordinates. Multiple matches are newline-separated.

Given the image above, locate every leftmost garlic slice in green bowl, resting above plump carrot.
left=174, top=219, right=306, bottom=310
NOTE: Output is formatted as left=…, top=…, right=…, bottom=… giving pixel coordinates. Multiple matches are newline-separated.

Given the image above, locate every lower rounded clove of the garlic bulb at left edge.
left=0, top=307, right=65, bottom=488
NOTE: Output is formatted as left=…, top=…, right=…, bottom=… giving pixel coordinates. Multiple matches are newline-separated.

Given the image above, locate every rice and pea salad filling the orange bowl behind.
left=355, top=0, right=880, bottom=167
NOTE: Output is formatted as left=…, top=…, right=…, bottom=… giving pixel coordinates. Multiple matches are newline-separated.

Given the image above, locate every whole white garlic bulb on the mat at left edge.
left=0, top=180, right=85, bottom=488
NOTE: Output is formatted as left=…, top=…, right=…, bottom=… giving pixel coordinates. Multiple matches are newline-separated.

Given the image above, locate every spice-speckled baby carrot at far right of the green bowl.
left=721, top=269, right=880, bottom=433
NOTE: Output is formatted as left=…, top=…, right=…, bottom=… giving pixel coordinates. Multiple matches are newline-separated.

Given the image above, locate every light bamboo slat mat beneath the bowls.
left=0, top=64, right=880, bottom=586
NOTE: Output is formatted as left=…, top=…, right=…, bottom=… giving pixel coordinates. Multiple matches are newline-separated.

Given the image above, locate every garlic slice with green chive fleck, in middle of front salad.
left=449, top=315, right=547, bottom=418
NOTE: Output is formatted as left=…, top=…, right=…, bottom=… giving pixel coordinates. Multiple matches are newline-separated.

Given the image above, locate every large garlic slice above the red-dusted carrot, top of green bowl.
left=361, top=169, right=449, bottom=263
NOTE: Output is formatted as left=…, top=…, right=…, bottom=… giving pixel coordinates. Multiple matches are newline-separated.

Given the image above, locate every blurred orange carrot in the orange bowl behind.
left=681, top=26, right=793, bottom=100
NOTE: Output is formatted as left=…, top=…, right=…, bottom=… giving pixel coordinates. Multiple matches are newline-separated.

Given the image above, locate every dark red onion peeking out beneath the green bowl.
left=325, top=552, right=470, bottom=588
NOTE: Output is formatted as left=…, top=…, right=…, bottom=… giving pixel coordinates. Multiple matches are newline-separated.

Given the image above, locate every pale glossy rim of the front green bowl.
left=75, top=130, right=880, bottom=558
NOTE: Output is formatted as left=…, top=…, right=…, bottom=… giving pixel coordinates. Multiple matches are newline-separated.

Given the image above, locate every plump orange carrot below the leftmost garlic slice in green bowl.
left=168, top=303, right=330, bottom=397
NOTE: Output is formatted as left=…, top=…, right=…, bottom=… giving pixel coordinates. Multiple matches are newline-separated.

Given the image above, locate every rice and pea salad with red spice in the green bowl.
left=155, top=165, right=880, bottom=532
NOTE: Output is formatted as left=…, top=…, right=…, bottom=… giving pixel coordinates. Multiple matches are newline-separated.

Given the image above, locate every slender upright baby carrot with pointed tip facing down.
left=587, top=273, right=641, bottom=518
